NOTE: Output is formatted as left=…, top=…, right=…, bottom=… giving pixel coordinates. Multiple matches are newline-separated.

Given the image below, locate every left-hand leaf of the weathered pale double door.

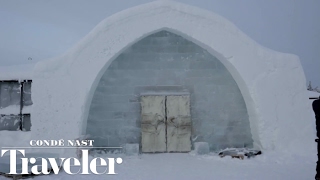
left=141, top=96, right=166, bottom=152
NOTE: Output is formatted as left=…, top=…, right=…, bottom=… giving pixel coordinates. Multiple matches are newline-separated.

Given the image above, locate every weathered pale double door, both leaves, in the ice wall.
left=141, top=95, right=191, bottom=152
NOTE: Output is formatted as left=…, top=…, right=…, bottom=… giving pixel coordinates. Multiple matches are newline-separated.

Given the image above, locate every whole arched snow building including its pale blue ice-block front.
left=1, top=1, right=315, bottom=153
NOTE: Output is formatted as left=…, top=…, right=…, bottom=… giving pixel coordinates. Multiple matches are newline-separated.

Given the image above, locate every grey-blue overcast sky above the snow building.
left=0, top=0, right=320, bottom=86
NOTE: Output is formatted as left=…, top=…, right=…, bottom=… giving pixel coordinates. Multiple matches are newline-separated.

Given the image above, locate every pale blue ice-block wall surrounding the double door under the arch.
left=86, top=31, right=253, bottom=151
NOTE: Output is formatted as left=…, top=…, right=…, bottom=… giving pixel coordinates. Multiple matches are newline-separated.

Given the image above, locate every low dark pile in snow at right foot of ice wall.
left=219, top=148, right=262, bottom=159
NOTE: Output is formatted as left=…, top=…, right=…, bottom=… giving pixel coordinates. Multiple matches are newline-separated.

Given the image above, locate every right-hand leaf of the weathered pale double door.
left=166, top=95, right=191, bottom=152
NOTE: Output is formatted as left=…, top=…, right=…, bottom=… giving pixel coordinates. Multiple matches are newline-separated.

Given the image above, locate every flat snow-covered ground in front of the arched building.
left=0, top=152, right=316, bottom=180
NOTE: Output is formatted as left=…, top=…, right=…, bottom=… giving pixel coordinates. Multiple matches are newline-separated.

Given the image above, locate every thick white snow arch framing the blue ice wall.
left=27, top=1, right=315, bottom=154
